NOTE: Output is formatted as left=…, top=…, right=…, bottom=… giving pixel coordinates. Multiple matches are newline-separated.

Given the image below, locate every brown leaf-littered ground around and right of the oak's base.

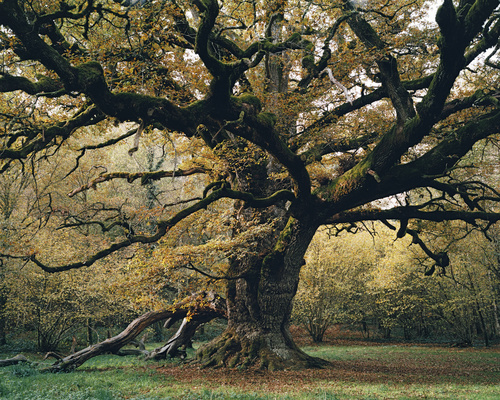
left=150, top=324, right=500, bottom=399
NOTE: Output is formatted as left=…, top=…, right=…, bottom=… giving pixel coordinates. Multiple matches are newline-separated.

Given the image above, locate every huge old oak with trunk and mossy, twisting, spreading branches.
left=0, top=0, right=500, bottom=368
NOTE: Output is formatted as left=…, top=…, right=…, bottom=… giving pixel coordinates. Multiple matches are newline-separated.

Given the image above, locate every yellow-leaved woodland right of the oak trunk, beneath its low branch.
left=293, top=223, right=499, bottom=346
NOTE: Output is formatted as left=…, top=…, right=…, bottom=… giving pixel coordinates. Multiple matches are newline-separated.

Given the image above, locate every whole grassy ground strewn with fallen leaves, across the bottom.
left=0, top=346, right=500, bottom=400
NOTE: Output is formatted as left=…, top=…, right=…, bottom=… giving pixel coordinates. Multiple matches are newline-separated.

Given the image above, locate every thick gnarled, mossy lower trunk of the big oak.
left=197, top=217, right=327, bottom=370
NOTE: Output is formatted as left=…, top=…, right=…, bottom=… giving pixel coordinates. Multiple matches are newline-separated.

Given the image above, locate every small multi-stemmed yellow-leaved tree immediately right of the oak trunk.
left=293, top=230, right=380, bottom=342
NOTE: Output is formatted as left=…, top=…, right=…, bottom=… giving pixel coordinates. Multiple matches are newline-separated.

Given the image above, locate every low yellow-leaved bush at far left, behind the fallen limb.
left=5, top=267, right=136, bottom=352
